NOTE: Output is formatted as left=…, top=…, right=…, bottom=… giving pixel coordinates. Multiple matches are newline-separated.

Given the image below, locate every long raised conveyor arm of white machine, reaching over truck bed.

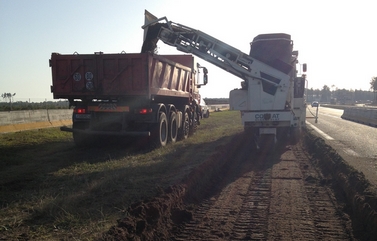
left=142, top=11, right=290, bottom=87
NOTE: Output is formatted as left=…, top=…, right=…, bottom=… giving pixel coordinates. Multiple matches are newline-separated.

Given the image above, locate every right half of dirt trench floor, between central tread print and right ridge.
left=268, top=145, right=353, bottom=240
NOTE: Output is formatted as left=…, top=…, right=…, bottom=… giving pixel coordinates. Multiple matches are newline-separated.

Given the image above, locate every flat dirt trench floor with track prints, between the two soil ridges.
left=173, top=142, right=353, bottom=240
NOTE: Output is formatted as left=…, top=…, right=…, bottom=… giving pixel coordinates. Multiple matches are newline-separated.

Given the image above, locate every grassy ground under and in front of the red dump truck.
left=0, top=111, right=243, bottom=240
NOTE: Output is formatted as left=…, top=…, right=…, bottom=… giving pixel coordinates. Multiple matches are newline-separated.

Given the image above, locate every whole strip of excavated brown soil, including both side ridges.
left=103, top=131, right=377, bottom=240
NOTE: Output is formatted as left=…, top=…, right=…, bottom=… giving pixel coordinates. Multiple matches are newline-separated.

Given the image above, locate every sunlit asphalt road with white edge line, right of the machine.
left=307, top=106, right=377, bottom=186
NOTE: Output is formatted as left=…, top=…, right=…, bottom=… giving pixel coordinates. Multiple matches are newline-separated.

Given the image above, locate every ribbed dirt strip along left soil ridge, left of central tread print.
left=173, top=137, right=264, bottom=240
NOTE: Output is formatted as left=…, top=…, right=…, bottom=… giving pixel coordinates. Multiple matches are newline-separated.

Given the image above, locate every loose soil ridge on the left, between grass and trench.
left=104, top=134, right=245, bottom=240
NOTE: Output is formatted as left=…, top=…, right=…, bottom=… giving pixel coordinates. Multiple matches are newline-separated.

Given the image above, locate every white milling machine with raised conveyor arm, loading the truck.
left=142, top=11, right=306, bottom=146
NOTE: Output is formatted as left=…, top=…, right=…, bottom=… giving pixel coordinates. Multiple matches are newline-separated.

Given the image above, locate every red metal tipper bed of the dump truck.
left=50, top=52, right=195, bottom=99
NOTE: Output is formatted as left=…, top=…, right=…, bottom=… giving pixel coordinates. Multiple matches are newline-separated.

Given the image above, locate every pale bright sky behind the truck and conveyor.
left=0, top=0, right=377, bottom=102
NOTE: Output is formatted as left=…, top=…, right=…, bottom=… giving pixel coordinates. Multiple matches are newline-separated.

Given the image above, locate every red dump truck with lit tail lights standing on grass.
left=50, top=52, right=208, bottom=146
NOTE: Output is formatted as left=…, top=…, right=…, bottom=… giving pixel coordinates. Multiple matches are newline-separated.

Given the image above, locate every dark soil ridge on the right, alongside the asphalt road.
left=305, top=132, right=377, bottom=240
